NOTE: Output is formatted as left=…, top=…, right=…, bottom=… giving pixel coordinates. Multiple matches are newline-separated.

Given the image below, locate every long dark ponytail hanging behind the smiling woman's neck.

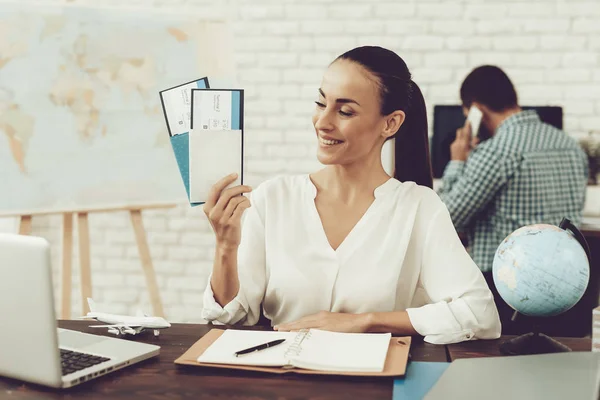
left=394, top=80, right=433, bottom=188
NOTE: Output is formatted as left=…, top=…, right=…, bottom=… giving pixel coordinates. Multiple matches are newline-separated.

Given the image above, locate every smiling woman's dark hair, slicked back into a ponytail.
left=334, top=46, right=433, bottom=188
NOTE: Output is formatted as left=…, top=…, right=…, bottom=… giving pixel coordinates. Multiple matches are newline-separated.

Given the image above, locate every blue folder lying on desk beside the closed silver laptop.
left=393, top=361, right=450, bottom=400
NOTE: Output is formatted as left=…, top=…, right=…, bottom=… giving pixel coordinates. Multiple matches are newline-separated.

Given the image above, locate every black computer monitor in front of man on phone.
left=430, top=105, right=563, bottom=178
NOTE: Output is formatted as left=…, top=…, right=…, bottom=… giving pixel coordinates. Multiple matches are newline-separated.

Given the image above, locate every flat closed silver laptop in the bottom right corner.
left=425, top=351, right=600, bottom=400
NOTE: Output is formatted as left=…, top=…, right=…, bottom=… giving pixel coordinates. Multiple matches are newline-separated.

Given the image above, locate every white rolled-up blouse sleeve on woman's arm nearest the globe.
left=406, top=203, right=501, bottom=344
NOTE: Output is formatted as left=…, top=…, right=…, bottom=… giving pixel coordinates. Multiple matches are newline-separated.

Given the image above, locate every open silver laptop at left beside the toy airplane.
left=0, top=233, right=160, bottom=388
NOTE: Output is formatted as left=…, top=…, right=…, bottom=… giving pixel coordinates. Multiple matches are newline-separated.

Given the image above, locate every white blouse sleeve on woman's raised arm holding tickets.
left=202, top=188, right=266, bottom=325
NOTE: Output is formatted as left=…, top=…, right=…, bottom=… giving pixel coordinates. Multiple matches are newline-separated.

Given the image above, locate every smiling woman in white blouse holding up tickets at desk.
left=202, top=47, right=500, bottom=343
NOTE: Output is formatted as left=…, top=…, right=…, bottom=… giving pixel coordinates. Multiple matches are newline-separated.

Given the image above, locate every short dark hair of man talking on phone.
left=460, top=65, right=518, bottom=112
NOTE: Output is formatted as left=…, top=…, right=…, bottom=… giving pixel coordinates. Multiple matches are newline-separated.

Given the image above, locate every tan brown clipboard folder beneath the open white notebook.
left=175, top=329, right=412, bottom=377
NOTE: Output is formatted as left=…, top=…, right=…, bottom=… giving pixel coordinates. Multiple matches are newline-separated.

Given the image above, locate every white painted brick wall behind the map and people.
left=5, top=0, right=600, bottom=321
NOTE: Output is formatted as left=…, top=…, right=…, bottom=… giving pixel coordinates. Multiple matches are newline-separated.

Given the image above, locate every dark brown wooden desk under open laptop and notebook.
left=0, top=321, right=447, bottom=400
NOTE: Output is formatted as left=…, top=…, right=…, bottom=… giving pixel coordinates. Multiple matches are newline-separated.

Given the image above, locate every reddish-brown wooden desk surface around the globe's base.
left=446, top=335, right=592, bottom=361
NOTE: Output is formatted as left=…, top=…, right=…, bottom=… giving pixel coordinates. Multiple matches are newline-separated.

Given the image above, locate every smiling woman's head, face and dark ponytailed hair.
left=313, top=47, right=433, bottom=188
